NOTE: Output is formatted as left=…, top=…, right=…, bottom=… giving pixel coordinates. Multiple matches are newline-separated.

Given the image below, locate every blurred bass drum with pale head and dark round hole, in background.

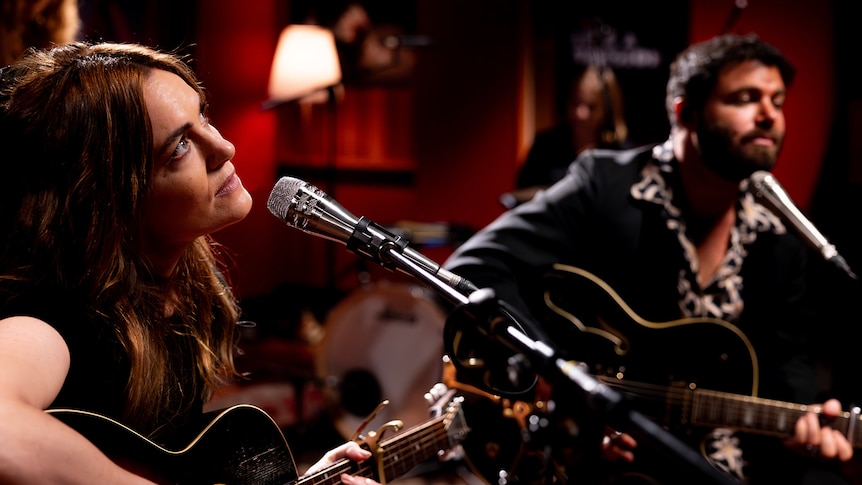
left=315, top=283, right=446, bottom=439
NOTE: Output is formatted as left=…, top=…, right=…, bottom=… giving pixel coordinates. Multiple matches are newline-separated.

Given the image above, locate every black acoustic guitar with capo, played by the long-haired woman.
left=47, top=391, right=467, bottom=485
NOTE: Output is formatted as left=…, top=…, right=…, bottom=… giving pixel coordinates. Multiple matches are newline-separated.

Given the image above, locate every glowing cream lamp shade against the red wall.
left=269, top=25, right=341, bottom=103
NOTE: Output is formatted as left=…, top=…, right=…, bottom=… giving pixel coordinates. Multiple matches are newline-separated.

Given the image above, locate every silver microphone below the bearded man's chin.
left=749, top=170, right=856, bottom=280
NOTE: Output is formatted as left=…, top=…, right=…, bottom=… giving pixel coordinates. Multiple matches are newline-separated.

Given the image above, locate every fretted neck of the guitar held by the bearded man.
left=684, top=389, right=862, bottom=447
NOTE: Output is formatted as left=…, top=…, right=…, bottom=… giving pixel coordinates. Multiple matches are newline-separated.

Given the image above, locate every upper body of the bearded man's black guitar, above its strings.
left=545, top=264, right=759, bottom=395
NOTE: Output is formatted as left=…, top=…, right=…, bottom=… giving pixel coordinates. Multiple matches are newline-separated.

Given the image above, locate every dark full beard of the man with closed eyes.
left=697, top=125, right=783, bottom=182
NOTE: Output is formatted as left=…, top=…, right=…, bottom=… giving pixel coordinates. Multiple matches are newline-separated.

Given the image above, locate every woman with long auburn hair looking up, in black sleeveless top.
left=0, top=43, right=376, bottom=484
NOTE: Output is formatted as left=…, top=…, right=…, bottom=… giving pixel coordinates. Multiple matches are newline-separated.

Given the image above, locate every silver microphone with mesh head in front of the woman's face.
left=267, top=177, right=478, bottom=294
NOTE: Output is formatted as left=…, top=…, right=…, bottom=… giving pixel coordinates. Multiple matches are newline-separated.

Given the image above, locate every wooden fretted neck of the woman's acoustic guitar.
left=296, top=416, right=452, bottom=485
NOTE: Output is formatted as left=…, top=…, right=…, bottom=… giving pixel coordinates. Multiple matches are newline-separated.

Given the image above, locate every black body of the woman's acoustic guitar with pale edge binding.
left=48, top=405, right=297, bottom=485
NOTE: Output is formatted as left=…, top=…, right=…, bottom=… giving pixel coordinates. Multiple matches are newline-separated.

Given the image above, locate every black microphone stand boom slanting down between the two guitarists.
left=380, top=246, right=739, bottom=485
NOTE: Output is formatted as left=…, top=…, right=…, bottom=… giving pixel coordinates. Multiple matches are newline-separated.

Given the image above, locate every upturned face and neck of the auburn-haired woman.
left=140, top=70, right=251, bottom=271
